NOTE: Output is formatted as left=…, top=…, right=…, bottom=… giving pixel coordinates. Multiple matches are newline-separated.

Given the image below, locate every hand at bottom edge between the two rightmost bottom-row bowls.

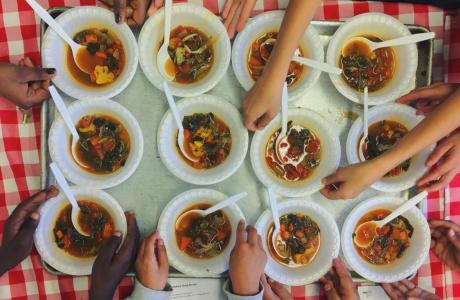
left=319, top=258, right=359, bottom=300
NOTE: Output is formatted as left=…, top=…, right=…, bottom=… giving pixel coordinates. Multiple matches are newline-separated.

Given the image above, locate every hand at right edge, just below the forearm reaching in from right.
left=417, top=130, right=460, bottom=192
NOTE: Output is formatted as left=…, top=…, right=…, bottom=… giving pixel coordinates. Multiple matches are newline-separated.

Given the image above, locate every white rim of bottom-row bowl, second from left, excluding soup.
left=158, top=189, right=245, bottom=277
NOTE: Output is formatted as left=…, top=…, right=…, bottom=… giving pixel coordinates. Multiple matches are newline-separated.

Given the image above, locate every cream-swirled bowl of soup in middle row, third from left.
left=250, top=108, right=341, bottom=197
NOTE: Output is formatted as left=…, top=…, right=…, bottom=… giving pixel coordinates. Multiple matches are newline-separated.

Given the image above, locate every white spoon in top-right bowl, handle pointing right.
left=342, top=32, right=435, bottom=56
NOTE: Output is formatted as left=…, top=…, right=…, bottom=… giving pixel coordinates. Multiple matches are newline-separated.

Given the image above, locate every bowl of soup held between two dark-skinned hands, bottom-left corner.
left=34, top=187, right=127, bottom=276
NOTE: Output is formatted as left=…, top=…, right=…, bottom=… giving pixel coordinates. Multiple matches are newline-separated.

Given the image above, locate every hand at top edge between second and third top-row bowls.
left=222, top=0, right=256, bottom=38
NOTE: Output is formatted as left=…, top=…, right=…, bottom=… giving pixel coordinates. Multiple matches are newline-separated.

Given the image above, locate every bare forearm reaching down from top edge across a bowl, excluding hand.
left=264, top=0, right=321, bottom=81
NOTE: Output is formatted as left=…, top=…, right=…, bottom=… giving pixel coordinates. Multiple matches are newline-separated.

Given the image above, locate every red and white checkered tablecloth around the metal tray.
left=0, top=0, right=460, bottom=300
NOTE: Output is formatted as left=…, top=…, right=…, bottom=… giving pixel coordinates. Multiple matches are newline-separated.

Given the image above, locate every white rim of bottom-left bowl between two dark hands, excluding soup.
left=34, top=187, right=127, bottom=276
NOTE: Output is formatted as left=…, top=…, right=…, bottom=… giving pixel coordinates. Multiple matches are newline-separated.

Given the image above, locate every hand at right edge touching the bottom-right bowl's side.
left=429, top=220, right=460, bottom=272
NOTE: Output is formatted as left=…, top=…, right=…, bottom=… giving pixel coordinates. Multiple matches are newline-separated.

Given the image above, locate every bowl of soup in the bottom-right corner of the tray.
left=341, top=195, right=431, bottom=282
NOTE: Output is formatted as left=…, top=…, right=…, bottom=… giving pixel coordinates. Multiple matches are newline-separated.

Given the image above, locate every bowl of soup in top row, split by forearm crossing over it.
left=232, top=11, right=324, bottom=101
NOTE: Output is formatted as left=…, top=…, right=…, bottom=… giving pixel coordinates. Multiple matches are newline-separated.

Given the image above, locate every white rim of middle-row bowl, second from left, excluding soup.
left=157, top=95, right=249, bottom=185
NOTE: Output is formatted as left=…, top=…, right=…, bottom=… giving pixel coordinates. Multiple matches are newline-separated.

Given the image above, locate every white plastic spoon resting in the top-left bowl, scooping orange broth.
left=26, top=0, right=95, bottom=74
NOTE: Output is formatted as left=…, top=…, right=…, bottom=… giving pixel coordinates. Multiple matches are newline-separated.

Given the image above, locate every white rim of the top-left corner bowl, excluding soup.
left=42, top=6, right=139, bottom=100
